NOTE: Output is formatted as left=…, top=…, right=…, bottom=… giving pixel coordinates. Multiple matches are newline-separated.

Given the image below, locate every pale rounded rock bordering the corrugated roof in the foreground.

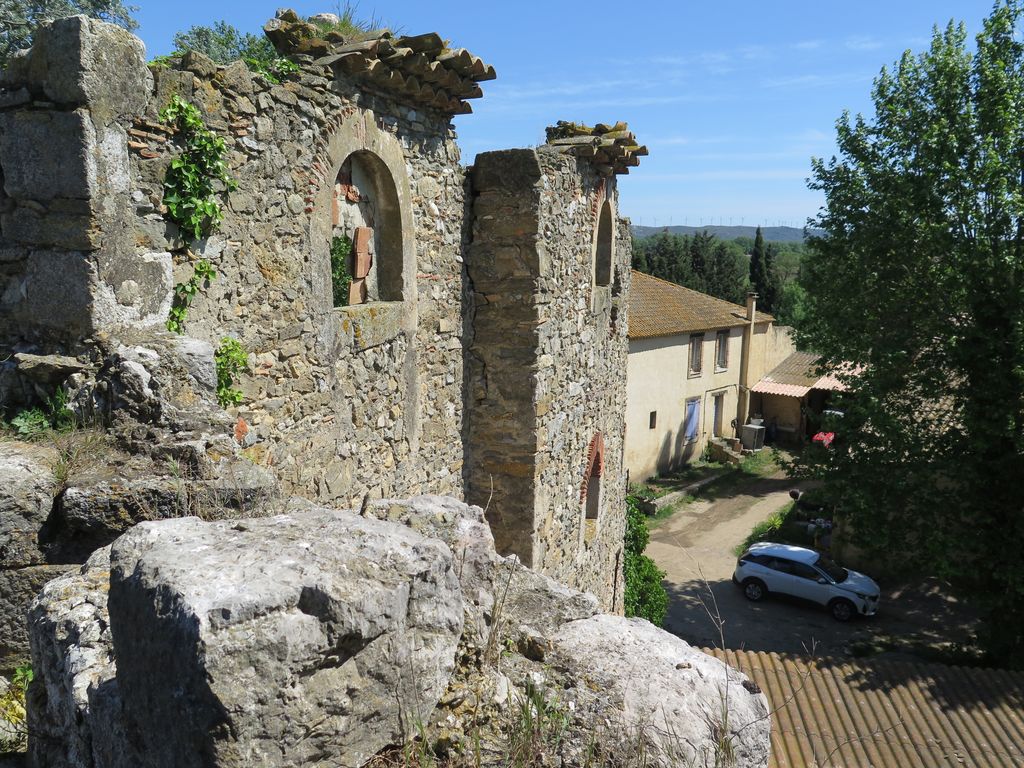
left=551, top=615, right=771, bottom=768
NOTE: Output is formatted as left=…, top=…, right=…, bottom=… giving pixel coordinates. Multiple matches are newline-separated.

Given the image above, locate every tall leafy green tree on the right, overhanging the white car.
left=797, top=0, right=1024, bottom=667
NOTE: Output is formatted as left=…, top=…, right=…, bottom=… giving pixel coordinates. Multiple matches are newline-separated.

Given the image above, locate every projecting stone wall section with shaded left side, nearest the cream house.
left=467, top=147, right=631, bottom=610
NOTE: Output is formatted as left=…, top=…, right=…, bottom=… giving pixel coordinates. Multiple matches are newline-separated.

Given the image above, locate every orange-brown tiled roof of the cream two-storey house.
left=630, top=269, right=775, bottom=339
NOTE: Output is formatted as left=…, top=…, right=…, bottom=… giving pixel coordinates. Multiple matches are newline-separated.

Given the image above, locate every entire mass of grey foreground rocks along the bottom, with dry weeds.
left=29, top=497, right=769, bottom=768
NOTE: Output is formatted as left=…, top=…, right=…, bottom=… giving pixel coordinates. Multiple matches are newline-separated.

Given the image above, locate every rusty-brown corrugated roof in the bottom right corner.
left=705, top=649, right=1024, bottom=768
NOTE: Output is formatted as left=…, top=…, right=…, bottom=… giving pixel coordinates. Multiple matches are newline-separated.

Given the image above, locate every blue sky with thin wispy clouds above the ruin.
left=134, top=0, right=992, bottom=226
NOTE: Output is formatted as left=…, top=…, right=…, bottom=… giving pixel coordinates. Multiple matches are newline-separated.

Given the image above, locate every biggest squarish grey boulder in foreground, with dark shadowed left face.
left=110, top=512, right=462, bottom=768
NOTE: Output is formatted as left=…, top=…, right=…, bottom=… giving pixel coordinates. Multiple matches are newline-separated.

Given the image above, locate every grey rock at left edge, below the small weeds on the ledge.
left=0, top=442, right=56, bottom=568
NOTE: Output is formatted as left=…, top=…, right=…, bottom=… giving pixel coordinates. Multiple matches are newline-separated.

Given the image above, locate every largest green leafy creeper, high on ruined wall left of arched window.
left=160, top=94, right=238, bottom=240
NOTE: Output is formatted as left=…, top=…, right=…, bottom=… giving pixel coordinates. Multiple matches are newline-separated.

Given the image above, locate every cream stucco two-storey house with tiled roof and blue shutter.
left=626, top=270, right=793, bottom=482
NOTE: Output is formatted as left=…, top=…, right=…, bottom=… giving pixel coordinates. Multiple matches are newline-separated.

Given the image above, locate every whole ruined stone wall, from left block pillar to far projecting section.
left=0, top=17, right=629, bottom=645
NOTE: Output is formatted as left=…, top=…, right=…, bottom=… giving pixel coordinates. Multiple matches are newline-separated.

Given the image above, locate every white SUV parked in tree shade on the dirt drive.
left=732, top=542, right=879, bottom=622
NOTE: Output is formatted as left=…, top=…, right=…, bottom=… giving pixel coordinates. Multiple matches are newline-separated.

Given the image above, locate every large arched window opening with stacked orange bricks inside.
left=331, top=151, right=402, bottom=306
